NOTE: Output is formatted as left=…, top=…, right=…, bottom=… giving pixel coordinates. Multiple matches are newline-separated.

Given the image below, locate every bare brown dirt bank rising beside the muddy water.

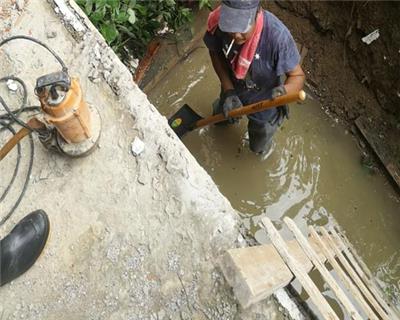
left=266, top=1, right=400, bottom=185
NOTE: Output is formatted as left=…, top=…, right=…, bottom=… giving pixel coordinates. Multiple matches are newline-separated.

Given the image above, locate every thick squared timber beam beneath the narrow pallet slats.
left=219, top=238, right=326, bottom=308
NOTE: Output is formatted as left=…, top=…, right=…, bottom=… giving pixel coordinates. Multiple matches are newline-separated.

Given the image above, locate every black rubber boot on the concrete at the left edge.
left=0, top=210, right=50, bottom=286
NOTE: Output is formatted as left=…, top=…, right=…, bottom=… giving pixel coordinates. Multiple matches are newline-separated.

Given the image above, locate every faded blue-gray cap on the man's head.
left=218, top=0, right=260, bottom=33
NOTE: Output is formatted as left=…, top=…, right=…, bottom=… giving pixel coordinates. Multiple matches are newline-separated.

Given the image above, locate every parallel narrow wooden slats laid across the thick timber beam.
left=262, top=217, right=400, bottom=320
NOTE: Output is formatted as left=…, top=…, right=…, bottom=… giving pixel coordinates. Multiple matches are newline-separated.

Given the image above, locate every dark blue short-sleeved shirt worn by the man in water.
left=204, top=10, right=300, bottom=122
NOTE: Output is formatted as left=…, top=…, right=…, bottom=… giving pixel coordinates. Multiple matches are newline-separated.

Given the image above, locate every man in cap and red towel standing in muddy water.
left=204, top=0, right=305, bottom=154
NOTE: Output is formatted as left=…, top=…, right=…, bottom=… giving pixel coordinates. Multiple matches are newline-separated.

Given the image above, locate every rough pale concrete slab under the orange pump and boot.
left=0, top=0, right=281, bottom=320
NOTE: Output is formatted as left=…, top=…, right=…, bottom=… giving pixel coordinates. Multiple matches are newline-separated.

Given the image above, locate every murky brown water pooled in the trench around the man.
left=149, top=48, right=400, bottom=308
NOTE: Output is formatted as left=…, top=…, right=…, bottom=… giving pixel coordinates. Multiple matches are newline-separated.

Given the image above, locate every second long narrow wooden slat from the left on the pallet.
left=283, top=217, right=362, bottom=320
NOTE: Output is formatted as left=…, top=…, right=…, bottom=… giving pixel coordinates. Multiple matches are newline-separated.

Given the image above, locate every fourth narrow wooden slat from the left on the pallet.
left=318, top=228, right=389, bottom=320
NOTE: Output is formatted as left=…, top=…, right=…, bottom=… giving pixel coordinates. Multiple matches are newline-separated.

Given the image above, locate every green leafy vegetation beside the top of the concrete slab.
left=77, top=0, right=211, bottom=57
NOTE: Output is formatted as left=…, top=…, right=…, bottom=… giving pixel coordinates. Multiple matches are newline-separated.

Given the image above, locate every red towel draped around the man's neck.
left=207, top=6, right=264, bottom=79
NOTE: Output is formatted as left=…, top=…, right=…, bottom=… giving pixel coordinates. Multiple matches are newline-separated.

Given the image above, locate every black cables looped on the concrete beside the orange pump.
left=0, top=35, right=68, bottom=226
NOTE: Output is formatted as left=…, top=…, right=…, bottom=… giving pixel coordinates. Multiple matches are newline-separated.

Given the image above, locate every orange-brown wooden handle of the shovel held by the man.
left=195, top=90, right=306, bottom=128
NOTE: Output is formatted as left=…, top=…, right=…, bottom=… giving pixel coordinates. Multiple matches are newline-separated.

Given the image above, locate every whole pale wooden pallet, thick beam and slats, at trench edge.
left=220, top=217, right=400, bottom=320
